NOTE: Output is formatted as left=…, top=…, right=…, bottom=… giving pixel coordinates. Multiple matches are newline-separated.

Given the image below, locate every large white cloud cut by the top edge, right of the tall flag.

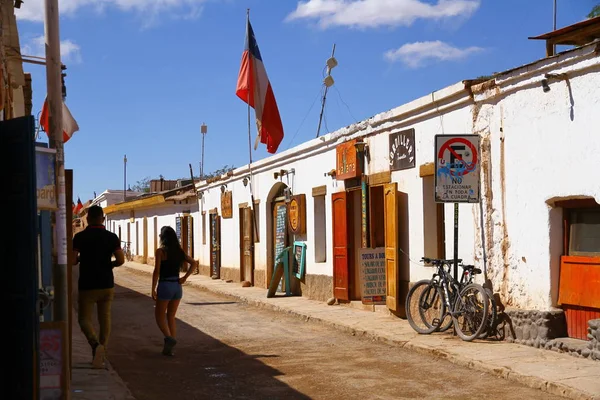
left=286, top=0, right=481, bottom=28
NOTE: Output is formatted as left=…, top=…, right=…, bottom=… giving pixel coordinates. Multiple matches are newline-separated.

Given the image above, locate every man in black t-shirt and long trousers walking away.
left=73, top=206, right=125, bottom=368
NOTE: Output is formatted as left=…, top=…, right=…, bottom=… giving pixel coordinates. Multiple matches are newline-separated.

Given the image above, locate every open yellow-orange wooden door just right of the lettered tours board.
left=383, top=182, right=400, bottom=311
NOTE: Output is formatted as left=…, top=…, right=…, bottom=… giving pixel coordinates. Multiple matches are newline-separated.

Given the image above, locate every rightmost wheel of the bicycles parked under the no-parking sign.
left=452, top=283, right=489, bottom=342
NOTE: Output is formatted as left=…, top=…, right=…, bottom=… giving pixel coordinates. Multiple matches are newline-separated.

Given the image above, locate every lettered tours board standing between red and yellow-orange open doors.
left=359, top=247, right=386, bottom=304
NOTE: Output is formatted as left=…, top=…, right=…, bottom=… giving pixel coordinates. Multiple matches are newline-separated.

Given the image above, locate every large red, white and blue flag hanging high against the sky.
left=235, top=18, right=283, bottom=154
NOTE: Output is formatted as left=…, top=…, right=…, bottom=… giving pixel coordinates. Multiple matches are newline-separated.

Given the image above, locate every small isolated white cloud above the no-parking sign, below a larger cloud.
left=384, top=40, right=483, bottom=68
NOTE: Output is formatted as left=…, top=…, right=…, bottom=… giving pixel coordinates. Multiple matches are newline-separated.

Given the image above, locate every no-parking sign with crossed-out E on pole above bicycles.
left=435, top=135, right=481, bottom=203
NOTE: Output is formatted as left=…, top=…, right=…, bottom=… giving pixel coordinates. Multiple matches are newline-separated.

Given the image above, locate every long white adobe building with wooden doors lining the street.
left=107, top=26, right=600, bottom=344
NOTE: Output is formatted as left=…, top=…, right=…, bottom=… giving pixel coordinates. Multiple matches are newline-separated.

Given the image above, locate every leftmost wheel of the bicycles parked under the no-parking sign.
left=406, top=279, right=444, bottom=334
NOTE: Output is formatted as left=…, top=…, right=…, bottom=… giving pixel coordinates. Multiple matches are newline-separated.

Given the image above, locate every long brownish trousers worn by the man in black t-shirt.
left=79, top=288, right=115, bottom=349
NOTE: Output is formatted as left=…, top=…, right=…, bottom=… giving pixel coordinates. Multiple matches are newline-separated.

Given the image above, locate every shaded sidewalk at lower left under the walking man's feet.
left=71, top=304, right=135, bottom=400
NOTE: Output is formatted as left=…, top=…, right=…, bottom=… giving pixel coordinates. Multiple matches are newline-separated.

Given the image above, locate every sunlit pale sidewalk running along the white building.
left=125, top=262, right=600, bottom=400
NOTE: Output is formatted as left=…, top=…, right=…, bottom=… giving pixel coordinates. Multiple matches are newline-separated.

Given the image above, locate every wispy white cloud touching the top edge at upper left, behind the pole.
left=15, top=0, right=207, bottom=25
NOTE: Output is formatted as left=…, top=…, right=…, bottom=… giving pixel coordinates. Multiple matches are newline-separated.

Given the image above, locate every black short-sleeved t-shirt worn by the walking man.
left=73, top=225, right=121, bottom=290
